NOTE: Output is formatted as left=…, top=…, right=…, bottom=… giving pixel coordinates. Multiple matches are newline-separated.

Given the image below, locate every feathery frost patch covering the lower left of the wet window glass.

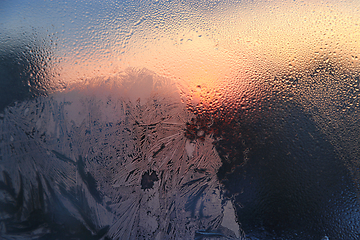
left=0, top=70, right=240, bottom=239
